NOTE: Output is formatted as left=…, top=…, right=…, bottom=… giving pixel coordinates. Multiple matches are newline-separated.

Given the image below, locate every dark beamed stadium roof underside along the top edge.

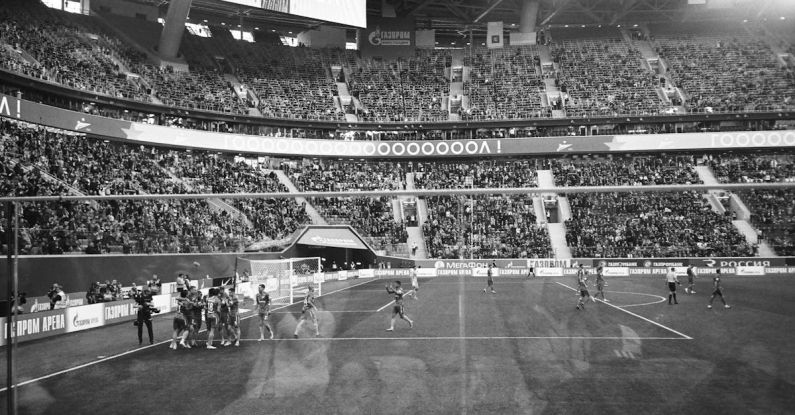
left=177, top=0, right=795, bottom=35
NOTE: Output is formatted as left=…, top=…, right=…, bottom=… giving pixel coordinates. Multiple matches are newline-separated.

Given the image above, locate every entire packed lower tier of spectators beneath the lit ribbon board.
left=0, top=117, right=795, bottom=258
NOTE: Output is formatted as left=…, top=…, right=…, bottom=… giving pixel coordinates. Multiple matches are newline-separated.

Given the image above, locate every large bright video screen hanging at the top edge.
left=223, top=0, right=367, bottom=28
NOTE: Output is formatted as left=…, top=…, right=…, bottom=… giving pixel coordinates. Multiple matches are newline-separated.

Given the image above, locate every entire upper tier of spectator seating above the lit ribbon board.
left=0, top=0, right=795, bottom=123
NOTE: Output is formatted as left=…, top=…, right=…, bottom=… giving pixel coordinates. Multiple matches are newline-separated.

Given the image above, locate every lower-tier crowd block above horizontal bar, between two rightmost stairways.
left=549, top=155, right=701, bottom=186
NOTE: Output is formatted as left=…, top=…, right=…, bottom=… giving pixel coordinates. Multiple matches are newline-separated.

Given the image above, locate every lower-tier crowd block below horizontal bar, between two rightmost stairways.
left=566, top=192, right=756, bottom=258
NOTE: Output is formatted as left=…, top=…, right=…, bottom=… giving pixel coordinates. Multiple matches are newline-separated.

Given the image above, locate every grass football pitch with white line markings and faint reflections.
left=0, top=277, right=795, bottom=414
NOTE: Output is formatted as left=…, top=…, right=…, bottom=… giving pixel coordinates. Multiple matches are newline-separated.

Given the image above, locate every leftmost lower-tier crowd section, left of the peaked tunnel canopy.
left=0, top=122, right=308, bottom=254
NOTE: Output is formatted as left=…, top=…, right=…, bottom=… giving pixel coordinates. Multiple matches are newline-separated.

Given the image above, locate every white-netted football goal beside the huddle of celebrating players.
left=236, top=257, right=323, bottom=304
